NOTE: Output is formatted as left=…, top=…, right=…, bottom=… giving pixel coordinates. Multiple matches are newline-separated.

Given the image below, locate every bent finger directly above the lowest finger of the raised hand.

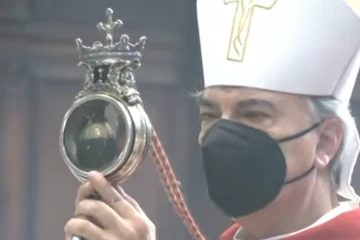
left=75, top=199, right=123, bottom=229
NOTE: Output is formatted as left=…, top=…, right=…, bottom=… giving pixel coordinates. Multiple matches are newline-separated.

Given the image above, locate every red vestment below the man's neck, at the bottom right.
left=220, top=208, right=360, bottom=240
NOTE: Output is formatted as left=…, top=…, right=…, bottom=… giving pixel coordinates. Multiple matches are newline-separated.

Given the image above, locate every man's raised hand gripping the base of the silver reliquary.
left=65, top=172, right=156, bottom=240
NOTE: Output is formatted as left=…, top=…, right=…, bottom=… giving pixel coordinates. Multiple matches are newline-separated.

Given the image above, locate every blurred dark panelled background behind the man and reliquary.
left=0, top=0, right=360, bottom=240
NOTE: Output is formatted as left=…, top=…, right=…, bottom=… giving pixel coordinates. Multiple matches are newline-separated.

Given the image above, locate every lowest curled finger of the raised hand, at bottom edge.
left=65, top=218, right=106, bottom=240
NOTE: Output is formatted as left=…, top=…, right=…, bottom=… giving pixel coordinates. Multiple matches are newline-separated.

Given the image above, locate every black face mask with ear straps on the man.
left=202, top=119, right=320, bottom=218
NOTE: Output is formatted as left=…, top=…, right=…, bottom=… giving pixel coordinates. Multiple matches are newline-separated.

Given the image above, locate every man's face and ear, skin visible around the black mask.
left=199, top=87, right=342, bottom=218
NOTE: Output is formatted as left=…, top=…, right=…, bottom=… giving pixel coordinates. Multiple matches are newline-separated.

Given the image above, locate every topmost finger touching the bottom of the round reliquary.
left=88, top=171, right=124, bottom=205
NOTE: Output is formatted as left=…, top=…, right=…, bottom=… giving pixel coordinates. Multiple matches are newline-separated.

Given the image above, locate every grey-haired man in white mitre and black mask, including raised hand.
left=66, top=0, right=360, bottom=240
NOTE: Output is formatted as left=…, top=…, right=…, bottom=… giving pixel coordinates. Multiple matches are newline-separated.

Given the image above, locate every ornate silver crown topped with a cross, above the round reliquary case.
left=76, top=8, right=146, bottom=103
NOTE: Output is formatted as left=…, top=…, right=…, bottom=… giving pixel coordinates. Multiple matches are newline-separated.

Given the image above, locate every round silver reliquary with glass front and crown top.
left=60, top=9, right=152, bottom=182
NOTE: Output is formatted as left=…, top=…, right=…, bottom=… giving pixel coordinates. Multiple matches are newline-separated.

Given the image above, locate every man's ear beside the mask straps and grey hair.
left=315, top=118, right=344, bottom=169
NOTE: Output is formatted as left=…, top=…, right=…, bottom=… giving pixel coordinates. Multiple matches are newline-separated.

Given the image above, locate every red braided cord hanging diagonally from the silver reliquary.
left=151, top=131, right=206, bottom=240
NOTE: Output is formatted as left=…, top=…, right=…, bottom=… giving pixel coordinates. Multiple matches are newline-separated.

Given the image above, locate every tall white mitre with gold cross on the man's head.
left=197, top=0, right=360, bottom=200
